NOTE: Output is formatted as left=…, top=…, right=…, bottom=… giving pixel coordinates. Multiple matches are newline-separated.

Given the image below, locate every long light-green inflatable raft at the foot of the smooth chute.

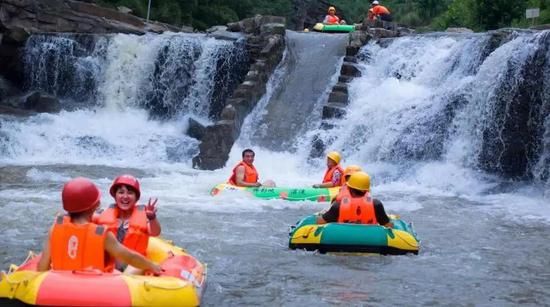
left=210, top=183, right=340, bottom=202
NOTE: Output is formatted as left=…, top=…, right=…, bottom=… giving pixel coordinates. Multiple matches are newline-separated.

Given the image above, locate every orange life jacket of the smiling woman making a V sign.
left=97, top=204, right=149, bottom=256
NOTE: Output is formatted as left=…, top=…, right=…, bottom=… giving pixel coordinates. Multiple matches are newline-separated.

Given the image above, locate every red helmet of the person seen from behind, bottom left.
left=61, top=177, right=101, bottom=213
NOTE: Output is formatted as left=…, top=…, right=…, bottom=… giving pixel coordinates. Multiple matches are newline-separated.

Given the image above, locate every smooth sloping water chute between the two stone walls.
left=238, top=31, right=348, bottom=151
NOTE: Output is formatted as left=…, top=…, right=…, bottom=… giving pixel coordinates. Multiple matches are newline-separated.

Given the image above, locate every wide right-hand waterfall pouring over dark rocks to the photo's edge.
left=314, top=31, right=550, bottom=185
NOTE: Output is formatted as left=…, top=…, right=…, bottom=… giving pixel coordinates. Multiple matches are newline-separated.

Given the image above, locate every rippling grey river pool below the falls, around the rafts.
left=0, top=153, right=550, bottom=306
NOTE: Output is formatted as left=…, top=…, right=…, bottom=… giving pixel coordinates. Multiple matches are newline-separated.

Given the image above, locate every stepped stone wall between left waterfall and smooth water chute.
left=193, top=16, right=285, bottom=170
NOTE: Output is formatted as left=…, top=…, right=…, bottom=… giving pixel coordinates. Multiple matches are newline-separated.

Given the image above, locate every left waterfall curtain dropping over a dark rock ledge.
left=24, top=33, right=248, bottom=118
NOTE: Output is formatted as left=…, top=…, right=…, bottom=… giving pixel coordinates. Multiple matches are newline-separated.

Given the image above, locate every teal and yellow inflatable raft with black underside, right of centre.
left=289, top=215, right=420, bottom=255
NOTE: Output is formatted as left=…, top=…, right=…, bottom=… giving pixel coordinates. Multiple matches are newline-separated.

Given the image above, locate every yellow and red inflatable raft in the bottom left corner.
left=0, top=237, right=206, bottom=306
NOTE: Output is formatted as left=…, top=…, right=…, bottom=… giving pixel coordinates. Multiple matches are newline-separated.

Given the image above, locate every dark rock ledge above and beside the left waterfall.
left=0, top=0, right=192, bottom=112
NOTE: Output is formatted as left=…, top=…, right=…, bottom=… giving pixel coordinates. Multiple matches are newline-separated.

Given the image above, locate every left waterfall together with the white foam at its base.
left=0, top=33, right=246, bottom=166
